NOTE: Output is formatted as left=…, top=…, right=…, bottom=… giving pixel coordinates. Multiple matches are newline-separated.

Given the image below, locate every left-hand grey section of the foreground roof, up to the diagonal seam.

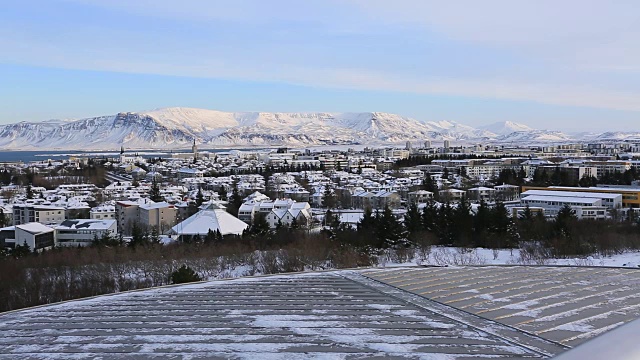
left=0, top=271, right=565, bottom=360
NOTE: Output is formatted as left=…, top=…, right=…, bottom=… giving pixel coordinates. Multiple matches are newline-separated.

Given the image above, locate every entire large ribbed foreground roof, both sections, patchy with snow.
left=0, top=266, right=640, bottom=359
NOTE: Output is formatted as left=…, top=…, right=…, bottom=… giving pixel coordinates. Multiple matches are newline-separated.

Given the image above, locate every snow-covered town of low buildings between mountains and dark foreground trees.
left=0, top=140, right=640, bottom=255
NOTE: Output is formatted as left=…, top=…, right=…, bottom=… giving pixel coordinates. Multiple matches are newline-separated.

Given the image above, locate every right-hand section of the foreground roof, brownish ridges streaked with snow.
left=363, top=266, right=640, bottom=353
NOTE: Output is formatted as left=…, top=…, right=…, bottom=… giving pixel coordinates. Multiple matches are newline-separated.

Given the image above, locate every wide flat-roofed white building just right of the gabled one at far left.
left=55, top=219, right=118, bottom=246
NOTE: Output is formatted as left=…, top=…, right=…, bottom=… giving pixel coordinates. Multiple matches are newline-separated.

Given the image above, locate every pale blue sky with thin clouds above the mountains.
left=0, top=0, right=640, bottom=132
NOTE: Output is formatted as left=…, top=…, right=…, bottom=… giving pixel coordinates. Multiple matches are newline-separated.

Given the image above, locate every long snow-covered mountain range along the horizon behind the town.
left=0, top=107, right=637, bottom=150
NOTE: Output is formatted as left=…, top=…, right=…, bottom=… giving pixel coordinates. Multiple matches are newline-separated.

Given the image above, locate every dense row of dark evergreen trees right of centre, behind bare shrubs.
left=325, top=199, right=640, bottom=257
